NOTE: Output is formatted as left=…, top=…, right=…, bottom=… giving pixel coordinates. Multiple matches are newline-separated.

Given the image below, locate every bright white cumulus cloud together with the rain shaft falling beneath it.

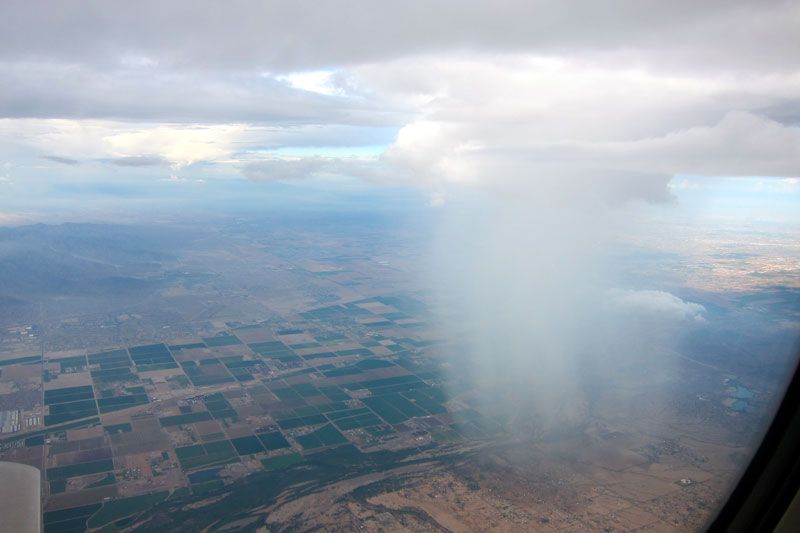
left=332, top=56, right=800, bottom=434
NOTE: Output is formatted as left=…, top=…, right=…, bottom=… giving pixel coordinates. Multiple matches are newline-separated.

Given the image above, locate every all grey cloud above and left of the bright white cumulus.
left=0, top=0, right=800, bottom=124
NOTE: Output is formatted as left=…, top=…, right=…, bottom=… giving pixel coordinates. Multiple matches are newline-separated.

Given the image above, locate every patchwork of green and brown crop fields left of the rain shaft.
left=4, top=297, right=482, bottom=531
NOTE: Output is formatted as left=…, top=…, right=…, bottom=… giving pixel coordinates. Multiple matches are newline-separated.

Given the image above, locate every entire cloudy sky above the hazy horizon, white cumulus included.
left=0, top=0, right=800, bottom=217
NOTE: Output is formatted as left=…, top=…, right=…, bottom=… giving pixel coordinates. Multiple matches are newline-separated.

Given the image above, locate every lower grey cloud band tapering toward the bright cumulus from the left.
left=0, top=62, right=399, bottom=126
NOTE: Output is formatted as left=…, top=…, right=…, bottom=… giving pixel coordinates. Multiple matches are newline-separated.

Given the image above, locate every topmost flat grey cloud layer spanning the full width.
left=0, top=0, right=800, bottom=70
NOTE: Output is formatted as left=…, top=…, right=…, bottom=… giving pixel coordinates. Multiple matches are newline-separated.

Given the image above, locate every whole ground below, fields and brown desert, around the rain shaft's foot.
left=0, top=218, right=795, bottom=532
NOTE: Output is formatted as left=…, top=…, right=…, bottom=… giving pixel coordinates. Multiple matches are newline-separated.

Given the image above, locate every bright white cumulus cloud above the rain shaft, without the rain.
left=356, top=56, right=800, bottom=198
